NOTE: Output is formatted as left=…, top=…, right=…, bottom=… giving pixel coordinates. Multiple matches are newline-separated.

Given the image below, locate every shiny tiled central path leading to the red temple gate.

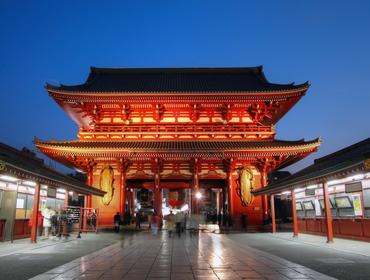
left=28, top=232, right=334, bottom=280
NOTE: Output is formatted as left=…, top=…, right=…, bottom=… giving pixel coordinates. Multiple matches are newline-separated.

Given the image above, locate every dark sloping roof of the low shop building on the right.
left=256, top=138, right=370, bottom=194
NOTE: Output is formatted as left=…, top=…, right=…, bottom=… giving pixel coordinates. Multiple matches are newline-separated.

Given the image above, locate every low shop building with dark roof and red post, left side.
left=0, top=143, right=105, bottom=242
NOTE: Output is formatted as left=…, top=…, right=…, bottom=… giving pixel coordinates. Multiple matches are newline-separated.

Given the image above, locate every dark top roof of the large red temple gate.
left=46, top=66, right=309, bottom=93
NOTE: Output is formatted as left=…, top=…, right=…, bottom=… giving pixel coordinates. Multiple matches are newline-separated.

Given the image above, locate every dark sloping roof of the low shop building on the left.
left=0, top=143, right=105, bottom=196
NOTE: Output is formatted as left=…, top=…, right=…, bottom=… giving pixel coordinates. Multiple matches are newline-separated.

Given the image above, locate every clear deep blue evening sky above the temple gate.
left=0, top=0, right=370, bottom=174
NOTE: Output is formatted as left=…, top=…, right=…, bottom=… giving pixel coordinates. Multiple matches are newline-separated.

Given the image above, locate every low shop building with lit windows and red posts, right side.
left=254, top=138, right=370, bottom=242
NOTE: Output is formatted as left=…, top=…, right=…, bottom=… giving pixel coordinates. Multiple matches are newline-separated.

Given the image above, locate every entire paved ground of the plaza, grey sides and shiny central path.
left=0, top=231, right=370, bottom=280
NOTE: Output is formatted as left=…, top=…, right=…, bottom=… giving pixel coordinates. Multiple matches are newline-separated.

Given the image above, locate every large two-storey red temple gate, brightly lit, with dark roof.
left=35, top=67, right=320, bottom=227
